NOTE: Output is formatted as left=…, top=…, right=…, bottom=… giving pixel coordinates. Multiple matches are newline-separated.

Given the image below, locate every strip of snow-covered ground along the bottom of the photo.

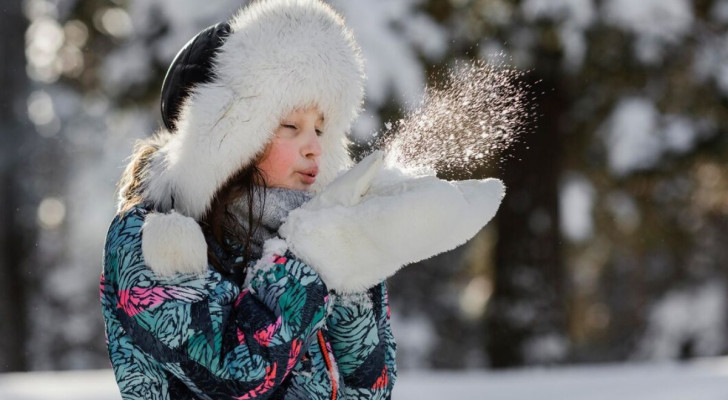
left=0, top=357, right=728, bottom=400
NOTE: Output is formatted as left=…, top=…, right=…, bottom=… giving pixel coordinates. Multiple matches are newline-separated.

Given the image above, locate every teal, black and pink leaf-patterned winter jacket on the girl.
left=100, top=207, right=396, bottom=400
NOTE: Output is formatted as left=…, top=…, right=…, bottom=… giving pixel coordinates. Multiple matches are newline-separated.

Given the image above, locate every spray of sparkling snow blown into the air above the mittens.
left=373, top=55, right=533, bottom=176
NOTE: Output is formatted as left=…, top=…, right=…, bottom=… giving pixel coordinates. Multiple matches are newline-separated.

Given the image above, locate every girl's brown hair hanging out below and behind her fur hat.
left=117, top=132, right=267, bottom=275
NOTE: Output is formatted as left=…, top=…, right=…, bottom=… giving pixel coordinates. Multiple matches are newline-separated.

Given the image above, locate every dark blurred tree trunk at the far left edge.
left=0, top=0, right=34, bottom=372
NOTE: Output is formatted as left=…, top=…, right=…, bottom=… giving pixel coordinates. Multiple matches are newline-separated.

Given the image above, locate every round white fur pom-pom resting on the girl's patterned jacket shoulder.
left=142, top=211, right=207, bottom=276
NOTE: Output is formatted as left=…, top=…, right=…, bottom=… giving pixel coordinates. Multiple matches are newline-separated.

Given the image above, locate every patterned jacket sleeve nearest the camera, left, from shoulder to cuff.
left=102, top=210, right=329, bottom=399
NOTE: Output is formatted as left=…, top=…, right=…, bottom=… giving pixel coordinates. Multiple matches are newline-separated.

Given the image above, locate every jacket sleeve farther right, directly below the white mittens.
left=326, top=282, right=397, bottom=399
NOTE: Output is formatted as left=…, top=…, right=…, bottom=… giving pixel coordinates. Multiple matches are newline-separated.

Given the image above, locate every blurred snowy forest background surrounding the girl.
left=0, top=0, right=728, bottom=399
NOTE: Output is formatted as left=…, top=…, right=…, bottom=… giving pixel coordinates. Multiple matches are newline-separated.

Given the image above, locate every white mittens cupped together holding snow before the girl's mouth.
left=279, top=152, right=504, bottom=293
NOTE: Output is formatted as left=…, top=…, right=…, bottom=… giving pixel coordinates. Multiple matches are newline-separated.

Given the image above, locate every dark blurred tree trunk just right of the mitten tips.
left=485, top=67, right=567, bottom=368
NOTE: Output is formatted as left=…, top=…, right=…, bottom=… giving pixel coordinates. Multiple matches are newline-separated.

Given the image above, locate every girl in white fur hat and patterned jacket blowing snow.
left=101, top=0, right=503, bottom=400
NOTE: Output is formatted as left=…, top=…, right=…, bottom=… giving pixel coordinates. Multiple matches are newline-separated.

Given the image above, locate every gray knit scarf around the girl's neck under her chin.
left=230, top=188, right=313, bottom=259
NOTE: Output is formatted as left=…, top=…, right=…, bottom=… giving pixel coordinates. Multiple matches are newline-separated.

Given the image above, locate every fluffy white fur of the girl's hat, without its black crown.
left=144, top=0, right=364, bottom=219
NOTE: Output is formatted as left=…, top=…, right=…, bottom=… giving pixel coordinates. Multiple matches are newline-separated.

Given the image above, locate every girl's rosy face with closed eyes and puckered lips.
left=257, top=107, right=324, bottom=190
